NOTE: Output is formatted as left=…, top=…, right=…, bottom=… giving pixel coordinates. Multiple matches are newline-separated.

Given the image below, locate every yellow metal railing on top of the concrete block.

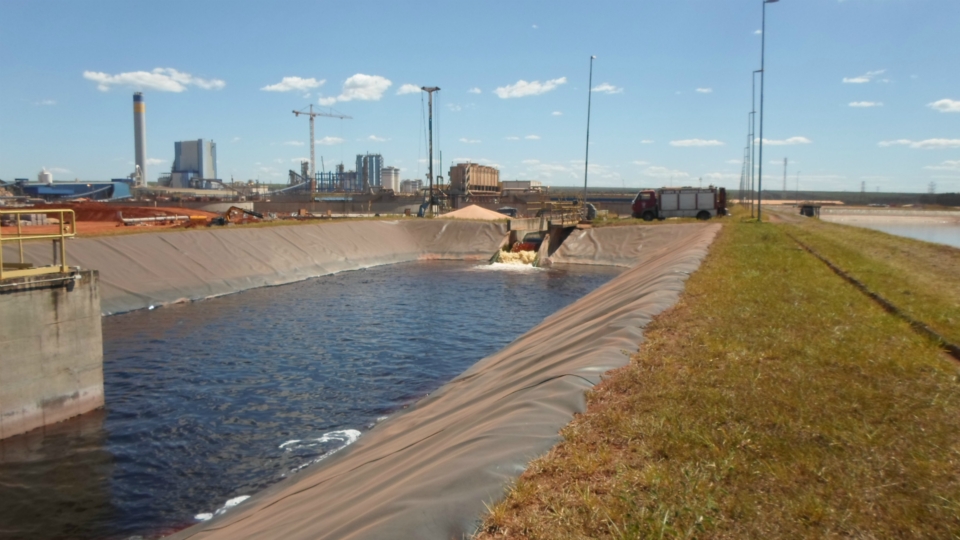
left=0, top=208, right=77, bottom=280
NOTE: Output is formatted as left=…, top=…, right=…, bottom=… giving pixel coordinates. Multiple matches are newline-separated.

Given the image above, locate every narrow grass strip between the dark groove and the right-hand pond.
left=785, top=220, right=960, bottom=343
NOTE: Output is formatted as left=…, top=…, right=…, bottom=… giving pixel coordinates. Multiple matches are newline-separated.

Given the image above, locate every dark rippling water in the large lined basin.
left=0, top=262, right=618, bottom=539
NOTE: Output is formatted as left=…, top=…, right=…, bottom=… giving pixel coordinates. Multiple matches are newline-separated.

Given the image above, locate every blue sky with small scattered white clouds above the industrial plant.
left=0, top=0, right=960, bottom=193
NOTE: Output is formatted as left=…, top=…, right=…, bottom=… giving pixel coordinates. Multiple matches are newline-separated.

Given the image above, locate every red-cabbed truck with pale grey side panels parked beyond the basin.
left=631, top=186, right=727, bottom=221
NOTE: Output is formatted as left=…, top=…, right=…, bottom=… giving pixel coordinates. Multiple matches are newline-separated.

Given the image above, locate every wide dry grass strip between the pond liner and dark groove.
left=479, top=213, right=960, bottom=539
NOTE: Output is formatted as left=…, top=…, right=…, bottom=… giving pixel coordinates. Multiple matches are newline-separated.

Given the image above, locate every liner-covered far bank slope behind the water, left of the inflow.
left=4, top=220, right=506, bottom=315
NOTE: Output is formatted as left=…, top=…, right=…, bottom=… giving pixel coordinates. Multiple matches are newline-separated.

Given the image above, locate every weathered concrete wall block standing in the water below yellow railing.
left=0, top=270, right=103, bottom=438
